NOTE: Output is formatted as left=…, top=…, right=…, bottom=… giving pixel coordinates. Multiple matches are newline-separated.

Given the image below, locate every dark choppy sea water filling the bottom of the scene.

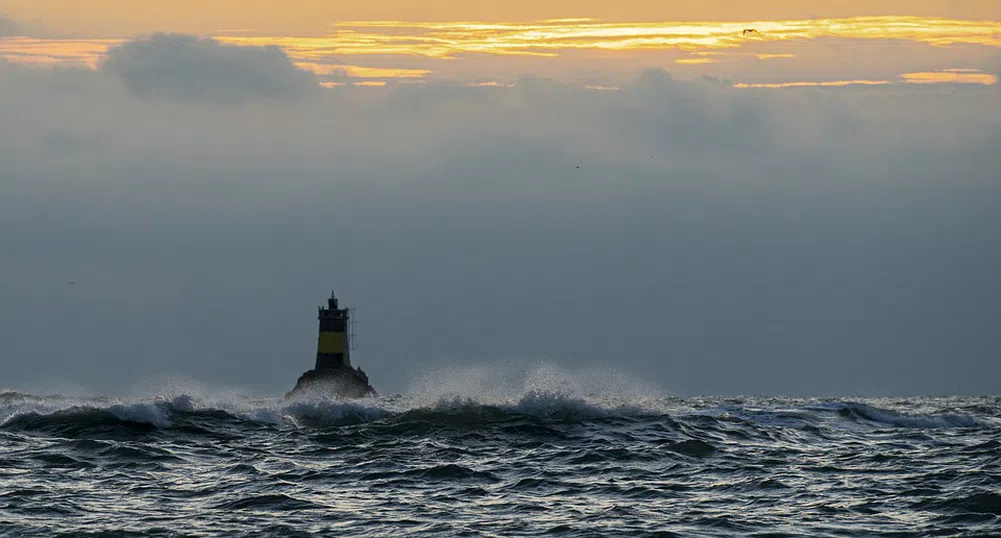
left=0, top=374, right=1001, bottom=536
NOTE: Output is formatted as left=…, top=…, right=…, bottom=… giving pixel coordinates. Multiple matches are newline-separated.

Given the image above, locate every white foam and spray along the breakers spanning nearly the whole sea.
left=0, top=384, right=987, bottom=428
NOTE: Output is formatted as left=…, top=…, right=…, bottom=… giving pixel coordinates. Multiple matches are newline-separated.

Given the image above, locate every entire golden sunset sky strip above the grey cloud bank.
left=0, top=0, right=1001, bottom=87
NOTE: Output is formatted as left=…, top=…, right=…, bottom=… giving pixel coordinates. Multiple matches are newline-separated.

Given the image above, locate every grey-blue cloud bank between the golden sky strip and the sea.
left=0, top=36, right=1001, bottom=395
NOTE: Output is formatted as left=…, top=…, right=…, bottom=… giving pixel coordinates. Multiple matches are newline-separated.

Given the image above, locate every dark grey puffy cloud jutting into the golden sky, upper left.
left=101, top=34, right=317, bottom=101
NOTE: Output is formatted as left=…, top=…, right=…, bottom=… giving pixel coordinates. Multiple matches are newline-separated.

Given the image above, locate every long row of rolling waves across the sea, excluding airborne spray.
left=0, top=385, right=987, bottom=438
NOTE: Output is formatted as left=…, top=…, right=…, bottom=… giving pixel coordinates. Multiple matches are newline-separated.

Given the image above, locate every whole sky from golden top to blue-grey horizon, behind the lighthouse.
left=0, top=0, right=1001, bottom=396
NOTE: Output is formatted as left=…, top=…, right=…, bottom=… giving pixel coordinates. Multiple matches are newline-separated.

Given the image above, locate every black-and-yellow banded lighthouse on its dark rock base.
left=285, top=293, right=378, bottom=399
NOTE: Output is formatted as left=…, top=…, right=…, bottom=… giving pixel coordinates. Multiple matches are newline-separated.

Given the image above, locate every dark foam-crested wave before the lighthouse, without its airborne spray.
left=0, top=392, right=654, bottom=437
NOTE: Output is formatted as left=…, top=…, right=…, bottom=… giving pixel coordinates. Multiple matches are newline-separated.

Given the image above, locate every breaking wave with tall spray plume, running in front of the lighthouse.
left=0, top=365, right=667, bottom=436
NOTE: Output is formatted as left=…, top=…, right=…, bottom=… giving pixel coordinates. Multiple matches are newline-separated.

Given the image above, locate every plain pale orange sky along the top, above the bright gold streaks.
left=0, top=0, right=1001, bottom=37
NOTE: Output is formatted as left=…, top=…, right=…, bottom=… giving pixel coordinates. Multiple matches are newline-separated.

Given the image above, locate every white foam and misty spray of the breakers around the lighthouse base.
left=0, top=361, right=665, bottom=428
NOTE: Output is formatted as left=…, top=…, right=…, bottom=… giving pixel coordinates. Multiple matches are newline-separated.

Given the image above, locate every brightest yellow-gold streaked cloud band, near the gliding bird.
left=215, top=17, right=1001, bottom=59
